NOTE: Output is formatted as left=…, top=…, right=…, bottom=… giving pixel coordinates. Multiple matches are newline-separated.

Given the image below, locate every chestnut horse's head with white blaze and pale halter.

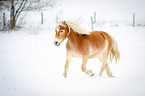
left=54, top=21, right=70, bottom=46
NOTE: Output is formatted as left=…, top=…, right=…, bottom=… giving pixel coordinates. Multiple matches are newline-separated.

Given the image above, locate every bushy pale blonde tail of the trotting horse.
left=110, top=38, right=120, bottom=63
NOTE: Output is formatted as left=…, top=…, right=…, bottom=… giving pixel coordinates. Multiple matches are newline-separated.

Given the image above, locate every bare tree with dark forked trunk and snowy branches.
left=0, top=0, right=56, bottom=29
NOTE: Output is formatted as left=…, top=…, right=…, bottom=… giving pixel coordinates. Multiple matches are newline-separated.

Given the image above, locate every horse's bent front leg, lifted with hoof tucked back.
left=82, top=57, right=94, bottom=76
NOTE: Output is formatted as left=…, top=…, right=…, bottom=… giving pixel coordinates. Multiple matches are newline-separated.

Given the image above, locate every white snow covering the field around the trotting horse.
left=0, top=0, right=145, bottom=96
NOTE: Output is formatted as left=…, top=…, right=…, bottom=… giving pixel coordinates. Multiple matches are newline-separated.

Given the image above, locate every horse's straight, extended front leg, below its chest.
left=63, top=52, right=72, bottom=78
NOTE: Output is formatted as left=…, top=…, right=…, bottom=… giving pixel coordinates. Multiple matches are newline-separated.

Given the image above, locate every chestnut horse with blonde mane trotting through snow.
left=54, top=21, right=120, bottom=78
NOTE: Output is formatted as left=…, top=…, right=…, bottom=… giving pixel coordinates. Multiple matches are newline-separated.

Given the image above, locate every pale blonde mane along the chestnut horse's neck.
left=57, top=21, right=90, bottom=35
